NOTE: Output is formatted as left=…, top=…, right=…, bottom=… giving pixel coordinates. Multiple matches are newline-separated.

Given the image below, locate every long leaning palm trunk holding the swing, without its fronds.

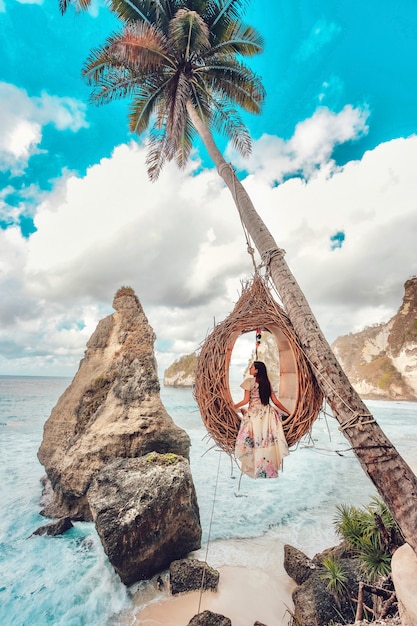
left=187, top=96, right=417, bottom=552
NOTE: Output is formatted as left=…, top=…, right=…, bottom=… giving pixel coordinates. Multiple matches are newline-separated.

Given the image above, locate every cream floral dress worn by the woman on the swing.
left=235, top=378, right=289, bottom=478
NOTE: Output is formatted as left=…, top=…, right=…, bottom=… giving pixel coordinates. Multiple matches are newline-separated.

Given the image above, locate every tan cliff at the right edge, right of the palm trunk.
left=332, top=278, right=417, bottom=401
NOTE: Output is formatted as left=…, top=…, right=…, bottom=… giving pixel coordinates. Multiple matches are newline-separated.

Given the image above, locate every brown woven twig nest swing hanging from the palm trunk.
left=194, top=274, right=323, bottom=455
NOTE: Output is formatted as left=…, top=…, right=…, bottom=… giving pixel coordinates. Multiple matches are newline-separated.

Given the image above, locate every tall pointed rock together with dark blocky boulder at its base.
left=38, top=287, right=201, bottom=584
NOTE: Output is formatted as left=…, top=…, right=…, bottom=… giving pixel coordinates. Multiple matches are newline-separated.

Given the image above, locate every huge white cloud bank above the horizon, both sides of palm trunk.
left=0, top=108, right=417, bottom=373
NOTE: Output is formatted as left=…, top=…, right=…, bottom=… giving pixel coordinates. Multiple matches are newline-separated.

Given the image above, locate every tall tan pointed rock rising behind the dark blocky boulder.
left=38, top=287, right=190, bottom=521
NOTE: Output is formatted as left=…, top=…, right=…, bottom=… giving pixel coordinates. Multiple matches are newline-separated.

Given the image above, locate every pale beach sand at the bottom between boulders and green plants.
left=130, top=536, right=295, bottom=626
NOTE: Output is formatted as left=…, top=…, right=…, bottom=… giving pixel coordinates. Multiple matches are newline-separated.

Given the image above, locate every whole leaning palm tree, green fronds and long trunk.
left=61, top=0, right=417, bottom=552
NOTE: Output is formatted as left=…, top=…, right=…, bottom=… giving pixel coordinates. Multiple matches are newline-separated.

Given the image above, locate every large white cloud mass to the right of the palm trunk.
left=240, top=136, right=417, bottom=339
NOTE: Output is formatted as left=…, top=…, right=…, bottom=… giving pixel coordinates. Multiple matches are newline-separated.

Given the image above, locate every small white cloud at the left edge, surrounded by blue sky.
left=0, top=82, right=87, bottom=175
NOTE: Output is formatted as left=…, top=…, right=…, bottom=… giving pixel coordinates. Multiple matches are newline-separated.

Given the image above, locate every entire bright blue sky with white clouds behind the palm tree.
left=0, top=0, right=417, bottom=375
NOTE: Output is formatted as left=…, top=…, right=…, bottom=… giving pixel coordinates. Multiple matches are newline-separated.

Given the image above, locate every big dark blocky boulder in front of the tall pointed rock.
left=87, top=453, right=201, bottom=585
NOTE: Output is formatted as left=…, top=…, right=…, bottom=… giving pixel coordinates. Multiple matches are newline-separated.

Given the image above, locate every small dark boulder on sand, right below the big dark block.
left=169, top=559, right=220, bottom=595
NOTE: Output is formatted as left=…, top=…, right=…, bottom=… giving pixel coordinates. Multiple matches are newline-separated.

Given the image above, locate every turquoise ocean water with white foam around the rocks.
left=0, top=376, right=417, bottom=626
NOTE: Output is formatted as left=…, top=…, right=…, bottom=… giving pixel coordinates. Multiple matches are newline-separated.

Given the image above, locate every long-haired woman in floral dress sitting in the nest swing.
left=234, top=361, right=290, bottom=478
